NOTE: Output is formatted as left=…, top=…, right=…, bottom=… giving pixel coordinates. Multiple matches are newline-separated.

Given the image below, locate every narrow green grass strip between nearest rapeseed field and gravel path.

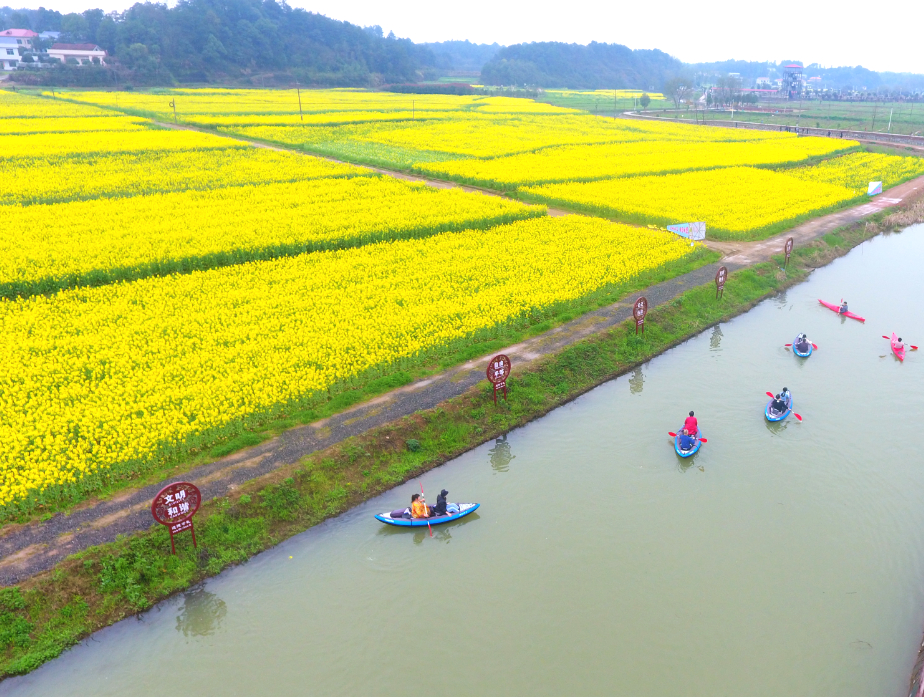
left=0, top=247, right=719, bottom=523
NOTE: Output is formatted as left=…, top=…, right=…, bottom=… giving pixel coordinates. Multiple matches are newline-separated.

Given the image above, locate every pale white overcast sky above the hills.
left=38, top=0, right=924, bottom=73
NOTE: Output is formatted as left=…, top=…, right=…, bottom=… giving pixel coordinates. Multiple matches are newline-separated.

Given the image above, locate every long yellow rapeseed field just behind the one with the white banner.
left=415, top=138, right=859, bottom=188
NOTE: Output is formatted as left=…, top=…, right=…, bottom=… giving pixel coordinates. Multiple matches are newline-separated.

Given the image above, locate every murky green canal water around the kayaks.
left=0, top=226, right=924, bottom=697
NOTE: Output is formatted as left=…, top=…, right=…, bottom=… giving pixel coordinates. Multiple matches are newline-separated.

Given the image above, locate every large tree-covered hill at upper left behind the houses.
left=0, top=0, right=436, bottom=86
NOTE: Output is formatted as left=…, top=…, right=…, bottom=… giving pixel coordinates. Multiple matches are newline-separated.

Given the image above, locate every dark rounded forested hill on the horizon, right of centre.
left=481, top=42, right=683, bottom=90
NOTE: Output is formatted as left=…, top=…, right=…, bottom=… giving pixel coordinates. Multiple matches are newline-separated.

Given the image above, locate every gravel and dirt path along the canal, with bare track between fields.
left=0, top=118, right=924, bottom=586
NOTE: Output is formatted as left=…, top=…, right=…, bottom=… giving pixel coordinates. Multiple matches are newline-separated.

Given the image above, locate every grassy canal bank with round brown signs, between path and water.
left=0, top=198, right=924, bottom=678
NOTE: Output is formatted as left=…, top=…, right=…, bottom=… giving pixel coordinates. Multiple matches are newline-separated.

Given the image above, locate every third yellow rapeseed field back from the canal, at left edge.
left=0, top=145, right=373, bottom=205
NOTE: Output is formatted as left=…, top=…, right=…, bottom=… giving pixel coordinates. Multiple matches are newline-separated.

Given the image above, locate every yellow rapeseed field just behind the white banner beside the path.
left=522, top=167, right=857, bottom=239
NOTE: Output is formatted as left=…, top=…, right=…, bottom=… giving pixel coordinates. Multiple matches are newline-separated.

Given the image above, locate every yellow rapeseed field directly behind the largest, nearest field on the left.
left=0, top=175, right=546, bottom=297
